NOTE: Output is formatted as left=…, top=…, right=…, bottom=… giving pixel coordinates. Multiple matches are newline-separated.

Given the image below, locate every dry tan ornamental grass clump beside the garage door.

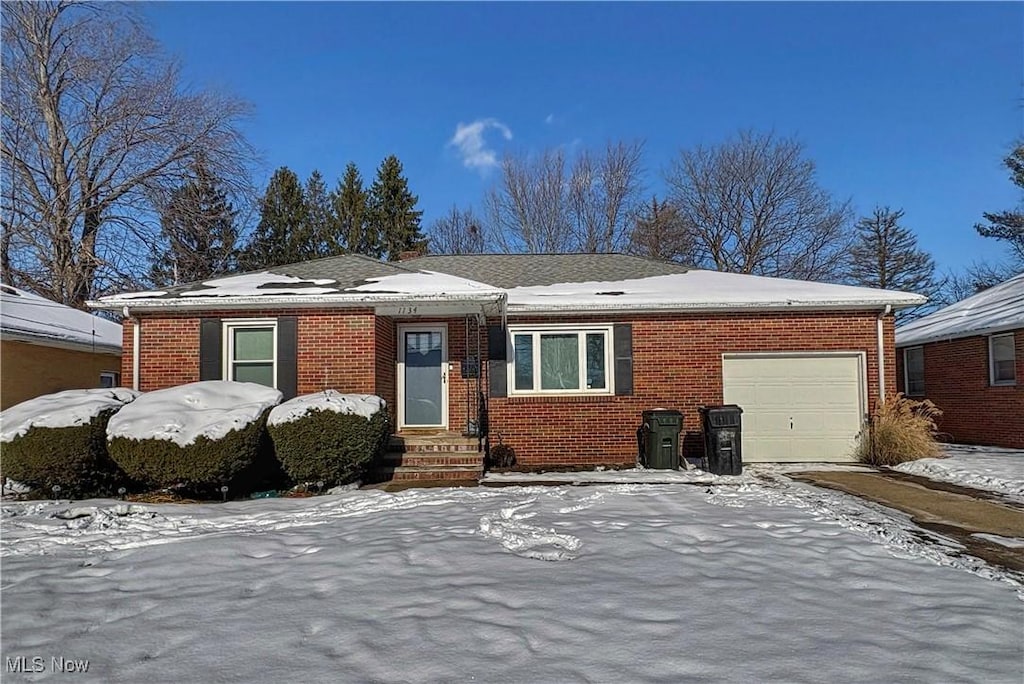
left=857, top=394, right=942, bottom=466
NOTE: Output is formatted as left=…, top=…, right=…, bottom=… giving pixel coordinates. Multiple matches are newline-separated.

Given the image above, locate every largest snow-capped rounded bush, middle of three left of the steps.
left=106, top=380, right=282, bottom=494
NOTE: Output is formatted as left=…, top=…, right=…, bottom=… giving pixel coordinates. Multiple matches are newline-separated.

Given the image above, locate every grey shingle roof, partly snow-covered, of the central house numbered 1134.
left=90, top=254, right=926, bottom=314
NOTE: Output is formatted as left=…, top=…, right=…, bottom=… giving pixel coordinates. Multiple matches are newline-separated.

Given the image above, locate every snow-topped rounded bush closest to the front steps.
left=267, top=389, right=390, bottom=485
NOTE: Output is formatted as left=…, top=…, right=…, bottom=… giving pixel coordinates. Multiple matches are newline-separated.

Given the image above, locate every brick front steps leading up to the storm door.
left=377, top=432, right=483, bottom=483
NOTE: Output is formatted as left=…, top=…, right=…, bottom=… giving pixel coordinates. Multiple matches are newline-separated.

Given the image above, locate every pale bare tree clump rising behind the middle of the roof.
left=484, top=142, right=643, bottom=253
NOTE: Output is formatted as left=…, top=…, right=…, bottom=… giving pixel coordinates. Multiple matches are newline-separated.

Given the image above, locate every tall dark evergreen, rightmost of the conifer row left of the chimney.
left=368, top=155, right=427, bottom=261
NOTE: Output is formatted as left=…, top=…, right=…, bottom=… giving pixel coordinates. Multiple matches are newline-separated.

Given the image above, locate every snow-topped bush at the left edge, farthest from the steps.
left=0, top=388, right=138, bottom=498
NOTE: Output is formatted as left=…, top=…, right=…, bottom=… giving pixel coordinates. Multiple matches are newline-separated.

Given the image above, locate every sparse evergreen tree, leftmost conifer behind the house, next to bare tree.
left=150, top=157, right=239, bottom=288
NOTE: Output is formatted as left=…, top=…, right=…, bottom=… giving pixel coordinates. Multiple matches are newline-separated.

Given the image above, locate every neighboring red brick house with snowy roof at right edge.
left=896, top=273, right=1024, bottom=448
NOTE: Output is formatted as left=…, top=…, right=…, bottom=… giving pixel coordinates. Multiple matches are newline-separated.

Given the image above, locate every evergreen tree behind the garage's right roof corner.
left=847, top=207, right=939, bottom=318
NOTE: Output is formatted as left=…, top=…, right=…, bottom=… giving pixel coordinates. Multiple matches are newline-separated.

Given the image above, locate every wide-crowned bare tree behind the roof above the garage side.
left=665, top=132, right=851, bottom=281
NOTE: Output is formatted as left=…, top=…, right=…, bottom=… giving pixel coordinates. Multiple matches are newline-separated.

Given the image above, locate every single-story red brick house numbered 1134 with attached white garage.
left=93, top=254, right=924, bottom=467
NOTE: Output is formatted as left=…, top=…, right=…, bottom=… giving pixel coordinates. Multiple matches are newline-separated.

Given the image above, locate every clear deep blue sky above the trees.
left=144, top=2, right=1024, bottom=269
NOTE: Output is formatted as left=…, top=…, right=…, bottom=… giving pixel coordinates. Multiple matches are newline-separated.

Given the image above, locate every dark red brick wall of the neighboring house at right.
left=898, top=329, right=1024, bottom=448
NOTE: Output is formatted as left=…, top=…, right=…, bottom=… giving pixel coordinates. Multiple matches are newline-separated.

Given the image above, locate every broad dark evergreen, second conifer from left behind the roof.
left=241, top=166, right=313, bottom=270
